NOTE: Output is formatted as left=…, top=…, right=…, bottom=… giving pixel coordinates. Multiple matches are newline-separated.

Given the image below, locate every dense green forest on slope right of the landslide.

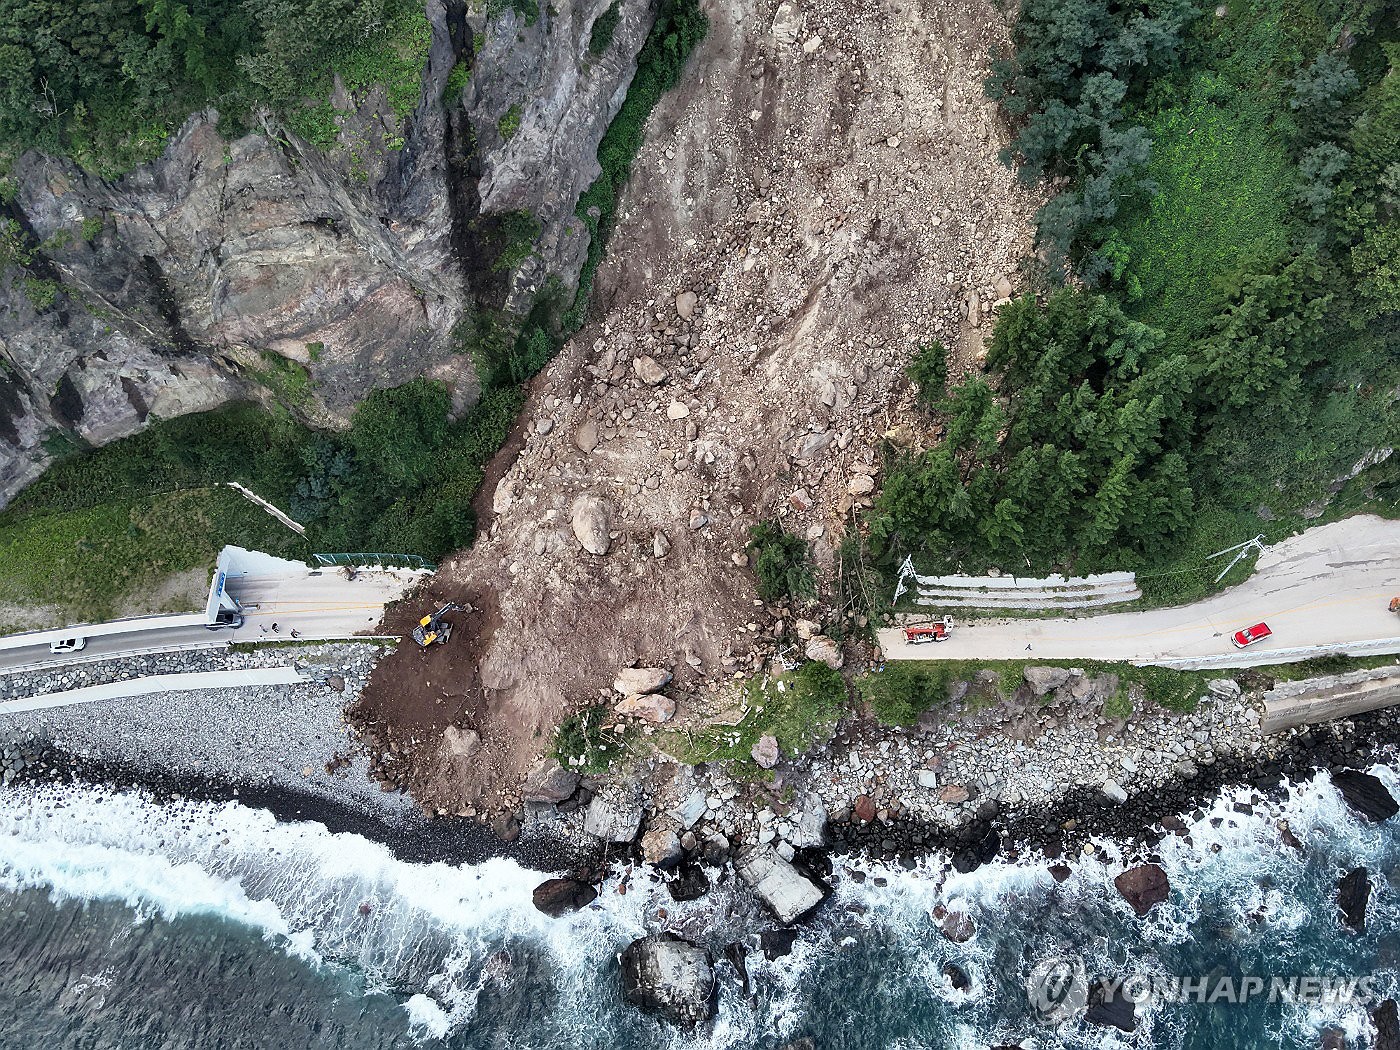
left=869, top=0, right=1400, bottom=599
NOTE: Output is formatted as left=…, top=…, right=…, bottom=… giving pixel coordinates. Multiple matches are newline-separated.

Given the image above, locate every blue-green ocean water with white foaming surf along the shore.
left=0, top=769, right=1400, bottom=1050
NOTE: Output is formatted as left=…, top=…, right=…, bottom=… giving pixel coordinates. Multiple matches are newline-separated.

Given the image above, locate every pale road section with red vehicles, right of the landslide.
left=879, top=514, right=1400, bottom=668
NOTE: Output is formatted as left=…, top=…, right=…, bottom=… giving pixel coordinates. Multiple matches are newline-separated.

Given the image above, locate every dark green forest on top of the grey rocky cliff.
left=0, top=0, right=430, bottom=175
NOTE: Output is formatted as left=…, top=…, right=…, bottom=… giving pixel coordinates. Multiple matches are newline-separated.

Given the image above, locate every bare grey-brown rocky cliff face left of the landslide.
left=0, top=0, right=651, bottom=505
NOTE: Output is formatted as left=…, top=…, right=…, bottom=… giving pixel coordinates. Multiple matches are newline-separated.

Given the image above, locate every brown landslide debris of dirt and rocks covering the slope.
left=364, top=0, right=1037, bottom=812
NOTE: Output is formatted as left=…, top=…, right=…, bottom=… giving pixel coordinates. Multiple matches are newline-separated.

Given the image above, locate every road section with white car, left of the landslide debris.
left=0, top=570, right=419, bottom=671
